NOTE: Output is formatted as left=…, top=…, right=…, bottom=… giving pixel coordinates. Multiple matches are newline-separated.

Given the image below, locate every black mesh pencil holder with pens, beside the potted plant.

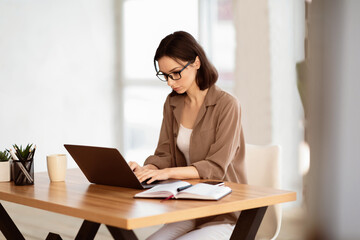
left=12, top=158, right=34, bottom=185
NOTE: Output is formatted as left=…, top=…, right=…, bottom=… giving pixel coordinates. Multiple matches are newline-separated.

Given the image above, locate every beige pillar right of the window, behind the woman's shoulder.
left=233, top=0, right=272, bottom=144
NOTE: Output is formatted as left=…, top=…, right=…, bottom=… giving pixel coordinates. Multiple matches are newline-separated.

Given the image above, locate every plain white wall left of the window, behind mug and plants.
left=0, top=0, right=115, bottom=171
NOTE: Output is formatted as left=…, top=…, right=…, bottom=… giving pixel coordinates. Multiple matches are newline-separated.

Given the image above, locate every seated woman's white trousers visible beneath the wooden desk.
left=147, top=220, right=235, bottom=240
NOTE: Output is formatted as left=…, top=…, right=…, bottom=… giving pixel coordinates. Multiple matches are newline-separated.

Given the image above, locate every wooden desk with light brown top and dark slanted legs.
left=0, top=169, right=296, bottom=239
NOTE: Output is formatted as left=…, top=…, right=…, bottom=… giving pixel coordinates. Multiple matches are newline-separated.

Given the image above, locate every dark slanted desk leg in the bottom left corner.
left=0, top=203, right=25, bottom=240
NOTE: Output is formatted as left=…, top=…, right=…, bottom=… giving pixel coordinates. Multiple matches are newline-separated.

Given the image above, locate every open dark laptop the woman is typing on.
left=64, top=144, right=158, bottom=189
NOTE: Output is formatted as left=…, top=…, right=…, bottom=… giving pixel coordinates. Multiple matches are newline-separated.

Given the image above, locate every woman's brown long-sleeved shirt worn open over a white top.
left=145, top=85, right=247, bottom=227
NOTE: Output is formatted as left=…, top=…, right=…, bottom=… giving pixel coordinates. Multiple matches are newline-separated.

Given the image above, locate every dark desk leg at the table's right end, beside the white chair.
left=230, top=207, right=267, bottom=240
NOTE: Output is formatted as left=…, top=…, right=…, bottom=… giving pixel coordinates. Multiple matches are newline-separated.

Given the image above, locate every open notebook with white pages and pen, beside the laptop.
left=134, top=181, right=231, bottom=200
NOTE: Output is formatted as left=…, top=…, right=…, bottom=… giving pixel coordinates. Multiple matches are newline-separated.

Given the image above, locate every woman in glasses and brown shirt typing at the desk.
left=129, top=31, right=246, bottom=240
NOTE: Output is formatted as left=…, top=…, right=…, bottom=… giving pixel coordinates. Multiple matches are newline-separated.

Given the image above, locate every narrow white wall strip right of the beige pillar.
left=268, top=0, right=305, bottom=202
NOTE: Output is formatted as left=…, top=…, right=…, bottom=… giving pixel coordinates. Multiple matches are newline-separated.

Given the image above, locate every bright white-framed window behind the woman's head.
left=122, top=0, right=235, bottom=164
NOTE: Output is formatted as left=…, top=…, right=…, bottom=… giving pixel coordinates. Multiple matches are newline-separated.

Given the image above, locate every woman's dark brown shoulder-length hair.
left=154, top=31, right=218, bottom=90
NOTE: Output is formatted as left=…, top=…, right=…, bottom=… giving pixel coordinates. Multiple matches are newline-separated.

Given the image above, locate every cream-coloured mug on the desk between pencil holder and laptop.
left=46, top=154, right=67, bottom=182
